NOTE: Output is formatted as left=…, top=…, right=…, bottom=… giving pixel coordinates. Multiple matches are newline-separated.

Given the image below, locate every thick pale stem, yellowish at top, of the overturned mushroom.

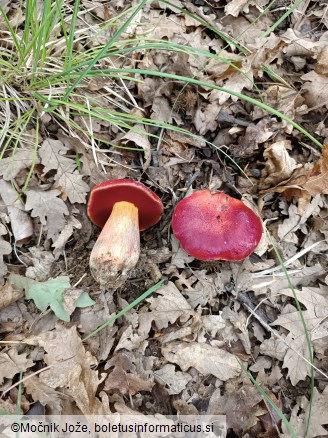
left=90, top=201, right=140, bottom=289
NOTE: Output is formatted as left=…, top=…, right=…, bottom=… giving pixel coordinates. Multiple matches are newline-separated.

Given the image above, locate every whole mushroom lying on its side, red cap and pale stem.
left=88, top=179, right=163, bottom=289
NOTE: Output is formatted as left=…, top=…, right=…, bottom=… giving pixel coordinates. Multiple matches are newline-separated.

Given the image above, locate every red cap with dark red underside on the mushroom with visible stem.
left=88, top=179, right=163, bottom=231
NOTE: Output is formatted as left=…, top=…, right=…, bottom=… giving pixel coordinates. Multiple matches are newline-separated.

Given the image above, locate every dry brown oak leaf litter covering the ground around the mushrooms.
left=0, top=0, right=328, bottom=437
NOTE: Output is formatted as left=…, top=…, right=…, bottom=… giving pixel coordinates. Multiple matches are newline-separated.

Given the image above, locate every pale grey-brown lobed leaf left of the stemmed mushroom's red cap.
left=25, top=190, right=68, bottom=241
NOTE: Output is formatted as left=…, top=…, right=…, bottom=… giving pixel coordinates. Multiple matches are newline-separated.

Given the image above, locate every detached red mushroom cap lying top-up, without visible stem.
left=172, top=190, right=262, bottom=260
